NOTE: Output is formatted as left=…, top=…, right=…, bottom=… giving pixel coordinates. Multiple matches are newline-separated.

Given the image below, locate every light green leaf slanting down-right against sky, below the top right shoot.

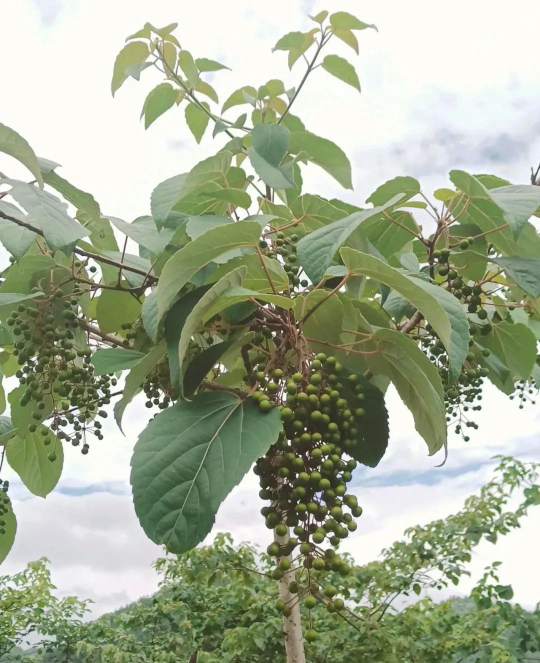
left=289, top=131, right=353, bottom=189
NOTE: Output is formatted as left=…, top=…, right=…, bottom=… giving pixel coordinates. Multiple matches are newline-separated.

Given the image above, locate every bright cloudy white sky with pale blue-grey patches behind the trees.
left=0, top=0, right=540, bottom=615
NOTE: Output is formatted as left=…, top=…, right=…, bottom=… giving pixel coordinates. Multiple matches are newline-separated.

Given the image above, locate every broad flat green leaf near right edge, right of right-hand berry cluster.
left=480, top=321, right=536, bottom=380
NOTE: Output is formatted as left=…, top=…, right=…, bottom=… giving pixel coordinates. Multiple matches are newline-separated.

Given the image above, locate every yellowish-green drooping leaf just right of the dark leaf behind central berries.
left=366, top=329, right=446, bottom=455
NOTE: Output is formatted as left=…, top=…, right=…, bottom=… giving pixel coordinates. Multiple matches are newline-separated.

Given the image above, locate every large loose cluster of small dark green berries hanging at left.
left=7, top=285, right=116, bottom=461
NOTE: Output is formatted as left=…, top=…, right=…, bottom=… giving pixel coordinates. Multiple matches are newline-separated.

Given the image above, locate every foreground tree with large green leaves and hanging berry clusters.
left=0, top=7, right=540, bottom=663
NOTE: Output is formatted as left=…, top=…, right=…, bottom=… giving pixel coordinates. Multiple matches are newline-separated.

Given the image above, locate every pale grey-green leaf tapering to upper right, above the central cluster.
left=297, top=194, right=401, bottom=283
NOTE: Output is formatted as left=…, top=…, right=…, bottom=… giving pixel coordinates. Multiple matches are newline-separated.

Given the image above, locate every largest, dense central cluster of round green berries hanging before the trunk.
left=251, top=353, right=365, bottom=628
